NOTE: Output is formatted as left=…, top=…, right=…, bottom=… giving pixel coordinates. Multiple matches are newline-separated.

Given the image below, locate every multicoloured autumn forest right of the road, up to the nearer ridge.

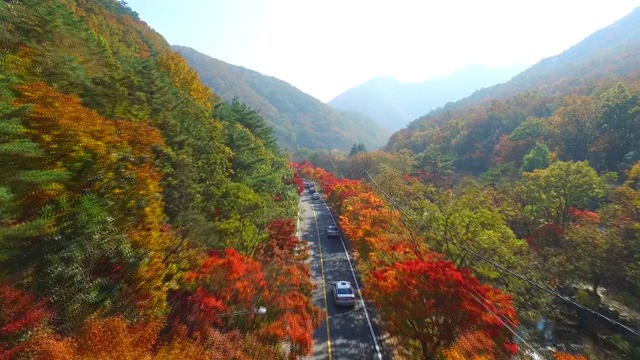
left=303, top=73, right=640, bottom=359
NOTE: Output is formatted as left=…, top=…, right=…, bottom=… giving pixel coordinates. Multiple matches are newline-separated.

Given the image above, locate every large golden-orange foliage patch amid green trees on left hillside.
left=18, top=83, right=177, bottom=316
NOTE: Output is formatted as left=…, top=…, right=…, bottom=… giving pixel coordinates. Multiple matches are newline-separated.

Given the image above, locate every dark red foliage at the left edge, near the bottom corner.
left=0, top=284, right=51, bottom=359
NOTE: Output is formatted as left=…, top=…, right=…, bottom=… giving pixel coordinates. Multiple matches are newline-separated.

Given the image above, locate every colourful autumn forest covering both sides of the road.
left=0, top=0, right=640, bottom=360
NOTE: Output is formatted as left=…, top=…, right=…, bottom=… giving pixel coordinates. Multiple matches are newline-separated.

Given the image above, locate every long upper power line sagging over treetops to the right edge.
left=365, top=170, right=640, bottom=336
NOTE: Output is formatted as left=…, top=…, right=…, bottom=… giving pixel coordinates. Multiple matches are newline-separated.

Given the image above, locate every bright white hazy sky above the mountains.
left=122, top=0, right=640, bottom=101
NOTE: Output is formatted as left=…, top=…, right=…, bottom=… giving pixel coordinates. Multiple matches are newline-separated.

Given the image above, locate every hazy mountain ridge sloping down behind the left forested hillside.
left=172, top=45, right=392, bottom=151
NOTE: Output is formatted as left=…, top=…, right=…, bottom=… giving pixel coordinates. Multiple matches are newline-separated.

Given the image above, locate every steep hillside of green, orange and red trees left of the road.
left=0, top=0, right=317, bottom=359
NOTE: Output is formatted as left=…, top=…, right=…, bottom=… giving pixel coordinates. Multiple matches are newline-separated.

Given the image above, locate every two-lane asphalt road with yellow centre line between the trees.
left=298, top=190, right=388, bottom=360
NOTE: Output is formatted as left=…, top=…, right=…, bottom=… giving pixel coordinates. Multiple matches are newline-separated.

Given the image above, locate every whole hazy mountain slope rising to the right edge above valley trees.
left=385, top=8, right=640, bottom=176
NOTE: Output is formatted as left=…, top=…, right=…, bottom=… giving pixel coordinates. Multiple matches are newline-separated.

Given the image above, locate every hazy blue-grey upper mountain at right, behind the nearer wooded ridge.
left=450, top=7, right=640, bottom=108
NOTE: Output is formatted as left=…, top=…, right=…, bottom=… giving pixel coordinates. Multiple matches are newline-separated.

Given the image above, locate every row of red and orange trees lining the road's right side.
left=299, top=164, right=518, bottom=360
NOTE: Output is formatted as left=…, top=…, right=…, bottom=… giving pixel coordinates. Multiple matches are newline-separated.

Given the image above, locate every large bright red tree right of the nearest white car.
left=365, top=255, right=518, bottom=360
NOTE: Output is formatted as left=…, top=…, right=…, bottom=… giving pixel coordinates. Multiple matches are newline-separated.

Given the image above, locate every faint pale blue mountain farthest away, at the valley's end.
left=329, top=65, right=526, bottom=130
